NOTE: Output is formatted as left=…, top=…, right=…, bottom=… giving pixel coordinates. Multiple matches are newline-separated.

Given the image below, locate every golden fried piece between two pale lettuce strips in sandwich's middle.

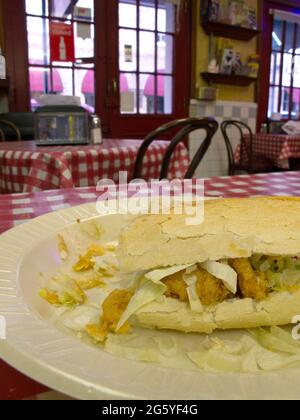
left=195, top=267, right=231, bottom=306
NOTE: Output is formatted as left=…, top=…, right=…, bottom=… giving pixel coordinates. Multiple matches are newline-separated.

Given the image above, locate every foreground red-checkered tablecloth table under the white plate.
left=0, top=172, right=300, bottom=399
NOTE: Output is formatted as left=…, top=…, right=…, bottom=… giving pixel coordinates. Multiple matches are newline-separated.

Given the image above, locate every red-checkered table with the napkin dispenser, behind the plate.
left=0, top=139, right=189, bottom=194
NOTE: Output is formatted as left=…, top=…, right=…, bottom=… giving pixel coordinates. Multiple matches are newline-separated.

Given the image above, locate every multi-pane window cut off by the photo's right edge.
left=268, top=10, right=300, bottom=120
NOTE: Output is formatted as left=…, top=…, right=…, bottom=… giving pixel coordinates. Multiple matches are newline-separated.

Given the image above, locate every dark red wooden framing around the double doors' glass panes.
left=2, top=0, right=195, bottom=138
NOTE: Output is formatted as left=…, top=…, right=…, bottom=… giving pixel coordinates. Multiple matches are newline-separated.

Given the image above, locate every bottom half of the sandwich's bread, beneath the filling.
left=135, top=290, right=300, bottom=334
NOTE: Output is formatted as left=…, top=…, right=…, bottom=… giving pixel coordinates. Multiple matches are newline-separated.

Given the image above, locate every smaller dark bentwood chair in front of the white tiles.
left=221, top=120, right=274, bottom=176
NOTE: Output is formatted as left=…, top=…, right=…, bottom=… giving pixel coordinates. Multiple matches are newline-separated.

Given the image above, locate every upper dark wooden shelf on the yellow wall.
left=202, top=21, right=260, bottom=41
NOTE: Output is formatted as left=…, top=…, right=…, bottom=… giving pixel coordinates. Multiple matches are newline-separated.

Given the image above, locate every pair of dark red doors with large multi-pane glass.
left=1, top=0, right=193, bottom=138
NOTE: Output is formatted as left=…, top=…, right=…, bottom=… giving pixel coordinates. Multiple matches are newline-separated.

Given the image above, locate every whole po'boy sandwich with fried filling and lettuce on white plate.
left=109, top=198, right=300, bottom=334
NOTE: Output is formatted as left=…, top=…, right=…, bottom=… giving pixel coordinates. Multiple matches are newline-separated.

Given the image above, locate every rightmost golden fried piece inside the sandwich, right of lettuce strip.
left=229, top=258, right=267, bottom=301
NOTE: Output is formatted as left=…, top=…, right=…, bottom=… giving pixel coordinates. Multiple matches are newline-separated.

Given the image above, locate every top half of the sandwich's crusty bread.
left=118, top=197, right=300, bottom=273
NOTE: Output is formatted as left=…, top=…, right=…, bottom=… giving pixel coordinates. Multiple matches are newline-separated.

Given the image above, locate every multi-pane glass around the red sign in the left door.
left=26, top=0, right=95, bottom=112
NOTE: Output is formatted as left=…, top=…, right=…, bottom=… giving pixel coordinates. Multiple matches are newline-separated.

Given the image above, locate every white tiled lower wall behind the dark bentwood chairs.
left=190, top=100, right=257, bottom=178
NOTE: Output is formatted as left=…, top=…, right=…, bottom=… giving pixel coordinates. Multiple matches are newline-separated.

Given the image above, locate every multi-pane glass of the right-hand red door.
left=119, top=0, right=176, bottom=114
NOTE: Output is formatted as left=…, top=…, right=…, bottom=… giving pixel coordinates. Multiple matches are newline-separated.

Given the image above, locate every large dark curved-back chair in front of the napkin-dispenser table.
left=133, top=118, right=219, bottom=179
